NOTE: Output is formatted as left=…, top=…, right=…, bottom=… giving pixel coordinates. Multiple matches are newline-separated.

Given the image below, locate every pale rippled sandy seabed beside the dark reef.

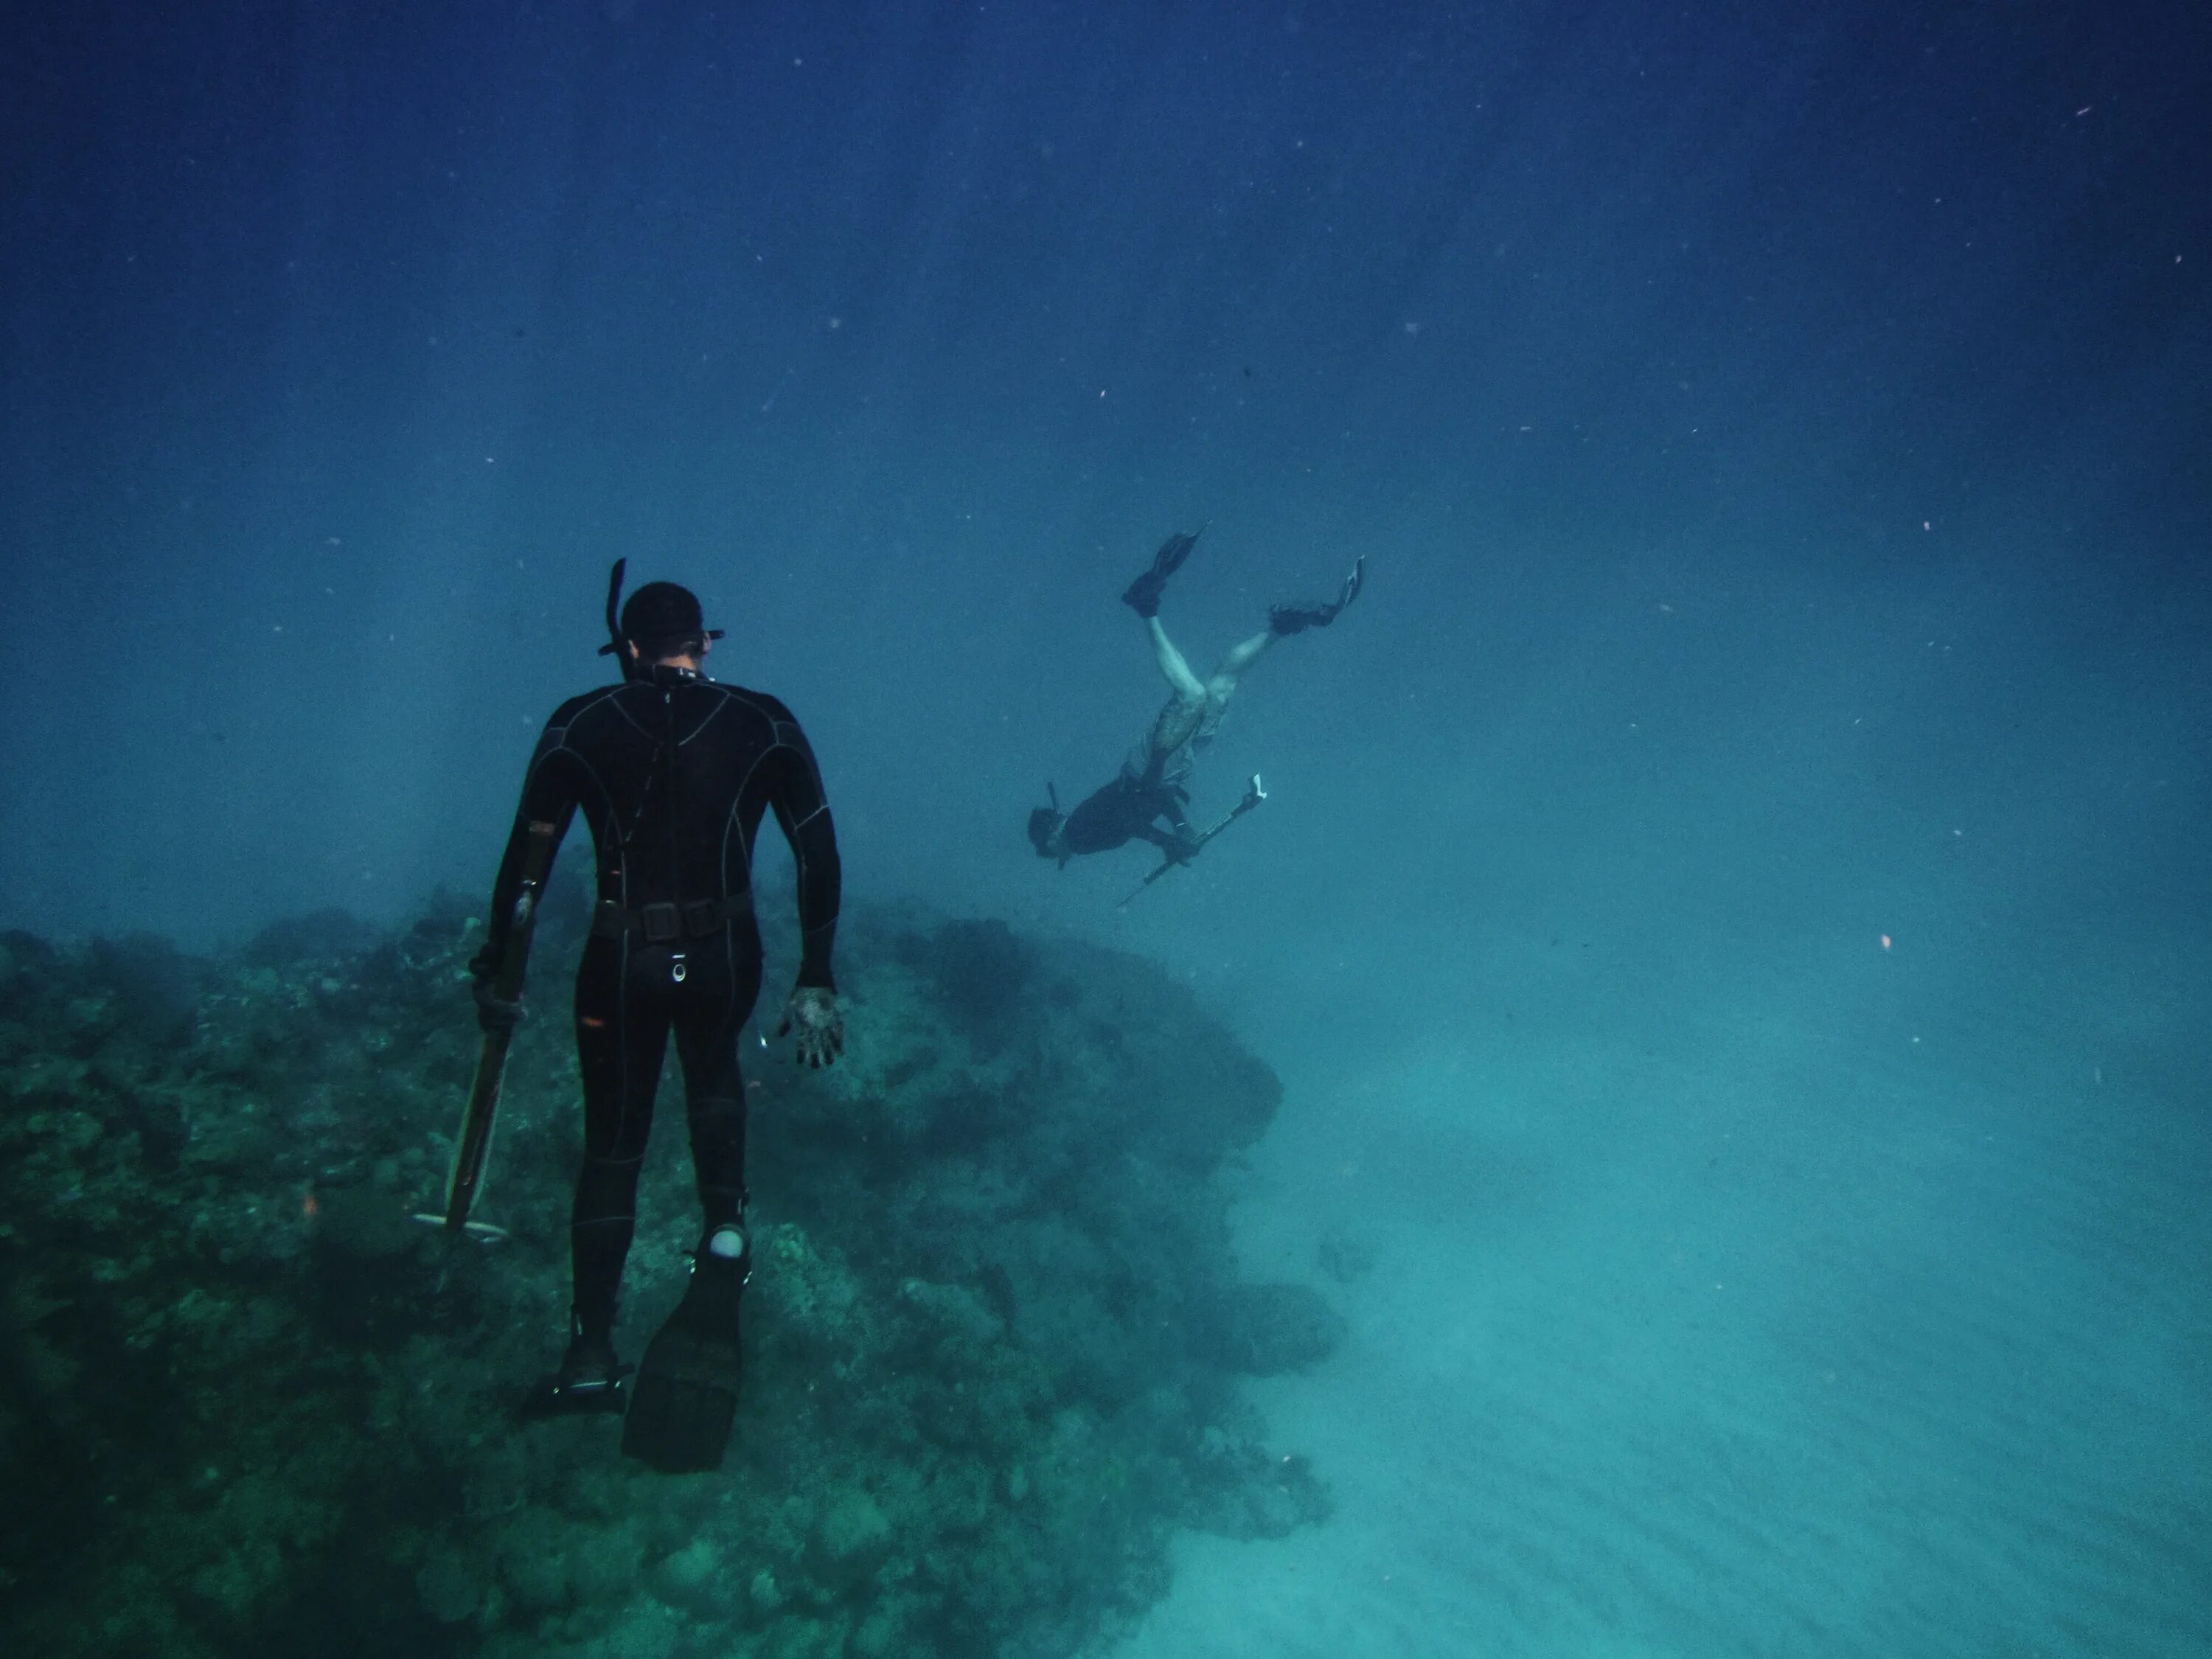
left=1117, top=938, right=2212, bottom=1659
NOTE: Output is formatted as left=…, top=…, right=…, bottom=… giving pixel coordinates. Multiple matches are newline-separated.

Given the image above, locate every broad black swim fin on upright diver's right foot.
left=622, top=1241, right=752, bottom=1475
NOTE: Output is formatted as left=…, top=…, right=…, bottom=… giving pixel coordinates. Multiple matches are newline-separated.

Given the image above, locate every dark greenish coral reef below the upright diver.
left=0, top=891, right=1336, bottom=1659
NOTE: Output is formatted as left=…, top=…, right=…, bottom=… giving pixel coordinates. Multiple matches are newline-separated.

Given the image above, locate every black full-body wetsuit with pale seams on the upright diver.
left=478, top=666, right=838, bottom=1336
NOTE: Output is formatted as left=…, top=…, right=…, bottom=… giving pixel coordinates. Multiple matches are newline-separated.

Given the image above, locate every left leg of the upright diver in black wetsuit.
left=568, top=940, right=668, bottom=1354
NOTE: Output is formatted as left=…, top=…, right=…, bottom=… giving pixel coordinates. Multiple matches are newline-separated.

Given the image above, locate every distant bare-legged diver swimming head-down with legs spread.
left=1029, top=533, right=1367, bottom=867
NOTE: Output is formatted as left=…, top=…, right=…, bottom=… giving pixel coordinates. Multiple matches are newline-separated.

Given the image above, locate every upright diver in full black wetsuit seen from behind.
left=471, top=564, right=845, bottom=1469
